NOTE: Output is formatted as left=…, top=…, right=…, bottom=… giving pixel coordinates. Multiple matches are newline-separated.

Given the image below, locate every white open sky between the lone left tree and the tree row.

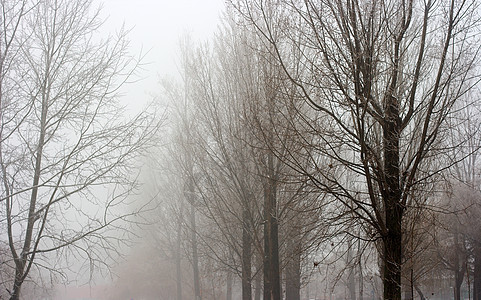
left=94, top=0, right=224, bottom=107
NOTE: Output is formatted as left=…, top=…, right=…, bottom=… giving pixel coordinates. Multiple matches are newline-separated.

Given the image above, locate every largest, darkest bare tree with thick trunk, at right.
left=232, top=0, right=479, bottom=299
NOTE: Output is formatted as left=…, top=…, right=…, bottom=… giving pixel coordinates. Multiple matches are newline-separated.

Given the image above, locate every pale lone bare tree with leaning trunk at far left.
left=0, top=0, right=160, bottom=300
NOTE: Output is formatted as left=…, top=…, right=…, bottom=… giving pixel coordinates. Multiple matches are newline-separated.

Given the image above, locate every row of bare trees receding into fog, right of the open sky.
left=114, top=0, right=481, bottom=300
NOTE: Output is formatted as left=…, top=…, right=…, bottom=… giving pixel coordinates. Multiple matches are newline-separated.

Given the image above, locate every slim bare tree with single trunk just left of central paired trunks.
left=180, top=26, right=261, bottom=299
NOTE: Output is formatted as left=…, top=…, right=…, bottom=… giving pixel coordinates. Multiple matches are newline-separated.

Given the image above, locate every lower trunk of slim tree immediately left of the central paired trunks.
left=242, top=208, right=252, bottom=300
